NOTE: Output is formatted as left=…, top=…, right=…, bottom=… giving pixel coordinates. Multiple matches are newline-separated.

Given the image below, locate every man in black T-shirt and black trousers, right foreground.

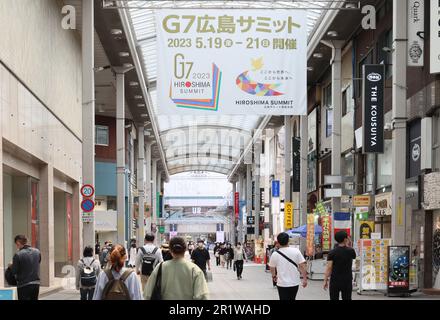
left=324, top=231, right=356, bottom=300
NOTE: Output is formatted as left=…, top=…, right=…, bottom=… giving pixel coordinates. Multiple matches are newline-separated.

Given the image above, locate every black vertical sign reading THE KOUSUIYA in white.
left=362, top=64, right=385, bottom=153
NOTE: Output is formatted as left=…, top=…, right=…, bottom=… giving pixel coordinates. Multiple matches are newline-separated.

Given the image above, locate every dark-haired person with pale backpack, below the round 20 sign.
left=76, top=246, right=101, bottom=300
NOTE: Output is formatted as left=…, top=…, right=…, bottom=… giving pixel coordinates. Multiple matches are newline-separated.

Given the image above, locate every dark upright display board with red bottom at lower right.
left=388, top=246, right=410, bottom=294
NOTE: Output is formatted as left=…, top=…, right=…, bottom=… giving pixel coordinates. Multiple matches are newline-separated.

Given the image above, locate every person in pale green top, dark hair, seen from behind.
left=144, top=237, right=208, bottom=300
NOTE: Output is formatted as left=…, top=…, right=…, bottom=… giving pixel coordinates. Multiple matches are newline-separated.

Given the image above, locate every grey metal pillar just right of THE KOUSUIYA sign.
left=391, top=0, right=408, bottom=245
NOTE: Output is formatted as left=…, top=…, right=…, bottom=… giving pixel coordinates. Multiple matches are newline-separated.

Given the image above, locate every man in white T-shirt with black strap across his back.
left=269, top=232, right=307, bottom=300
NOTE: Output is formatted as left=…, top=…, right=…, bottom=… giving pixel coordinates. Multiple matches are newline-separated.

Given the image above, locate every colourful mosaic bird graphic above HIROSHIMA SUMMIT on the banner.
left=236, top=58, right=284, bottom=97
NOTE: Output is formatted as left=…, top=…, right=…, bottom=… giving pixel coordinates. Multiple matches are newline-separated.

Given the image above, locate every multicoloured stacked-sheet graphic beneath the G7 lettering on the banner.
left=170, top=63, right=222, bottom=111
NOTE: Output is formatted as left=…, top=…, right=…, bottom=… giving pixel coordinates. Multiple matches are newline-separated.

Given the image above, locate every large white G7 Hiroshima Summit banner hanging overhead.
left=156, top=9, right=307, bottom=115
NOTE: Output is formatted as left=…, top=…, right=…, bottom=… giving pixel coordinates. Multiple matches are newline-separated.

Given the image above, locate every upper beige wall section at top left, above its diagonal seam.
left=0, top=0, right=82, bottom=137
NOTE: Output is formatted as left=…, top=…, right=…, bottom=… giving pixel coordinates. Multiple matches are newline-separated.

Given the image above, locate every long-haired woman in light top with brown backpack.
left=93, top=244, right=142, bottom=300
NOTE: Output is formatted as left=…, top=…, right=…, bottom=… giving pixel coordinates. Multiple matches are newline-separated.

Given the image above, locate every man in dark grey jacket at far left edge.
left=8, top=235, right=41, bottom=300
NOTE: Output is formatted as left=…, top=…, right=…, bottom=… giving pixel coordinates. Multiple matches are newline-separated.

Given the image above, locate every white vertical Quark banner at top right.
left=408, top=0, right=425, bottom=67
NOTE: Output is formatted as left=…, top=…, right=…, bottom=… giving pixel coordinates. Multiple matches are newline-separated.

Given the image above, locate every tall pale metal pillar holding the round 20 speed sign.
left=81, top=1, right=95, bottom=250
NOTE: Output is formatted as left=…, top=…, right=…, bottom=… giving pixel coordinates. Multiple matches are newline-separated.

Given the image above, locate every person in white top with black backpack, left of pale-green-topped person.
left=136, top=233, right=163, bottom=291
